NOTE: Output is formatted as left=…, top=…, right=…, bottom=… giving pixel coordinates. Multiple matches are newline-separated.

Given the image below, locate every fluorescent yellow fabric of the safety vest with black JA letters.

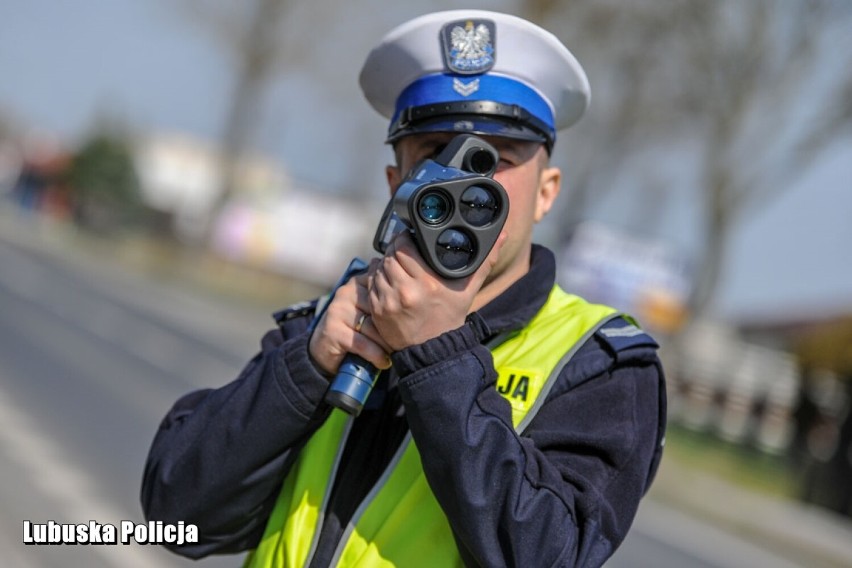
left=245, top=286, right=619, bottom=568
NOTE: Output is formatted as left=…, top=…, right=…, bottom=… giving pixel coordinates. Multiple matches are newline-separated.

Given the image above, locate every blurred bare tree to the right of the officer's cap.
left=521, top=0, right=852, bottom=313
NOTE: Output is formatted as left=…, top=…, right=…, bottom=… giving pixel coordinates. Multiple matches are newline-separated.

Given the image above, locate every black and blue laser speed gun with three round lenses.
left=317, top=134, right=509, bottom=416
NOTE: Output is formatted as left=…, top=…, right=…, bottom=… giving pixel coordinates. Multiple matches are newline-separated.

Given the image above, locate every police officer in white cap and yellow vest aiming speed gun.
left=142, top=10, right=665, bottom=567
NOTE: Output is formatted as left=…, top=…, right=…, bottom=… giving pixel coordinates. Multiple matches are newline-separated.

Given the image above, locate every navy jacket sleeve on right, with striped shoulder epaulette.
left=394, top=318, right=665, bottom=566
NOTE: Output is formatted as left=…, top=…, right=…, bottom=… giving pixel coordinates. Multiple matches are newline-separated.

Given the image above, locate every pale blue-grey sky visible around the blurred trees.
left=0, top=0, right=852, bottom=319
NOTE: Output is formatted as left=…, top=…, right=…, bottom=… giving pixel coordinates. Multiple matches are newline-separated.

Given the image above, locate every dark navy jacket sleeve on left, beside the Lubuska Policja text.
left=141, top=316, right=328, bottom=558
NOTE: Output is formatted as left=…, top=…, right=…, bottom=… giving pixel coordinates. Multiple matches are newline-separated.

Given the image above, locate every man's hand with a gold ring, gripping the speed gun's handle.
left=308, top=274, right=392, bottom=376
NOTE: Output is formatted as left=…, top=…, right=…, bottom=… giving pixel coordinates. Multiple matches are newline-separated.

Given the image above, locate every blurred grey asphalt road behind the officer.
left=0, top=223, right=794, bottom=568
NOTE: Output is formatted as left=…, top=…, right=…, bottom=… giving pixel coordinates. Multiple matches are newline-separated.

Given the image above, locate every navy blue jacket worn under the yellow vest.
left=142, top=246, right=666, bottom=566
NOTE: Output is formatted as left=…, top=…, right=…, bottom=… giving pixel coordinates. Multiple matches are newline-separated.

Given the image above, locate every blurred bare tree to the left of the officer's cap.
left=179, top=0, right=398, bottom=242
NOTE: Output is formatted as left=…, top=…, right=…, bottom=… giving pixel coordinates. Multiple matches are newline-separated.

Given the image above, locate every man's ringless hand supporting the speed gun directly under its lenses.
left=368, top=232, right=505, bottom=351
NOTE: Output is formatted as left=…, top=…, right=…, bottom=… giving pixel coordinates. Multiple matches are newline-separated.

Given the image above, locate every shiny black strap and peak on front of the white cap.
left=388, top=101, right=556, bottom=153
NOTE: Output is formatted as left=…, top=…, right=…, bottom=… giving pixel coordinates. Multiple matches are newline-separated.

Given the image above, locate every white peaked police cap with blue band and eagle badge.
left=359, top=10, right=590, bottom=147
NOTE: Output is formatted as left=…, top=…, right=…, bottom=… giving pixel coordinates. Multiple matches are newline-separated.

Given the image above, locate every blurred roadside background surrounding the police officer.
left=0, top=0, right=852, bottom=567
